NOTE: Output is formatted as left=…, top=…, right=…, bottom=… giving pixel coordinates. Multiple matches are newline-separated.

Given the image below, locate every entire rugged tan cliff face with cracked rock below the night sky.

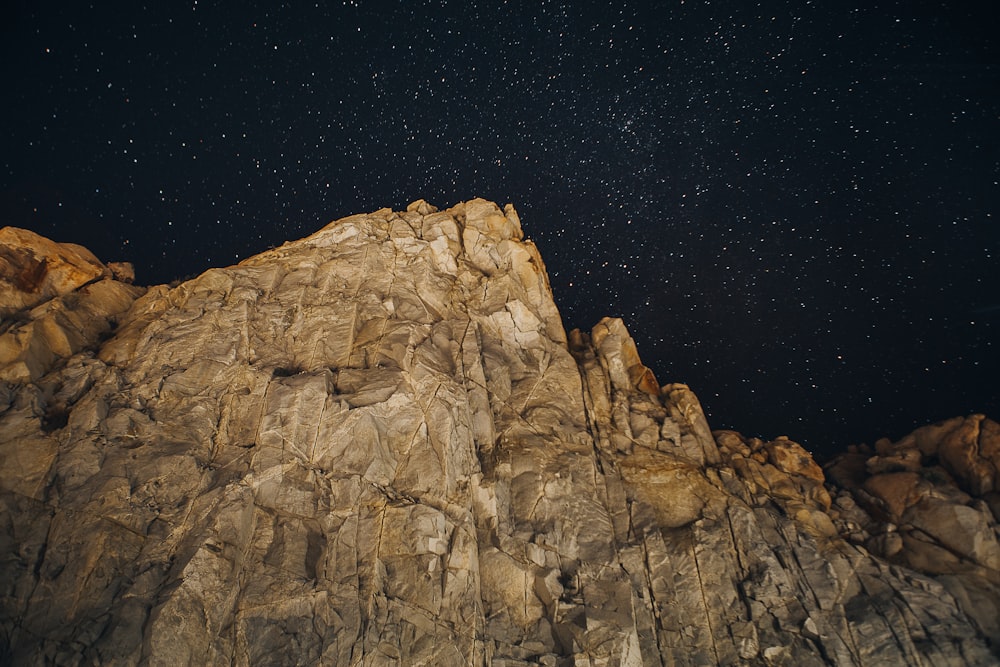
left=0, top=200, right=1000, bottom=666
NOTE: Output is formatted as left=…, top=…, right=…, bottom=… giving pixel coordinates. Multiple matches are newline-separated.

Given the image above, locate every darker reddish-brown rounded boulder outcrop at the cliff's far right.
left=827, top=415, right=1000, bottom=646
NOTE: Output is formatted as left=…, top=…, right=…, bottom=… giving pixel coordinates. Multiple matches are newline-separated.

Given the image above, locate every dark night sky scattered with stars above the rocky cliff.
left=0, top=0, right=1000, bottom=452
